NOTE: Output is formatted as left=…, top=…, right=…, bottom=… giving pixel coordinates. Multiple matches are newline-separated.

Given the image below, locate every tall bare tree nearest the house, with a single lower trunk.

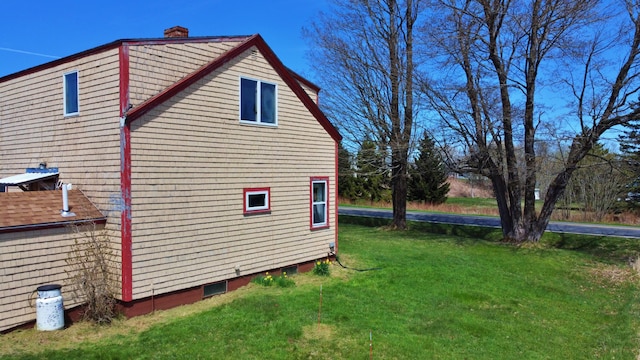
left=306, top=0, right=420, bottom=229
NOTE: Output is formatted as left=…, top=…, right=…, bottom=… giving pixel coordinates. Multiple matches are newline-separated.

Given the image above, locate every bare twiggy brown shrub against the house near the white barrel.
left=65, top=223, right=118, bottom=324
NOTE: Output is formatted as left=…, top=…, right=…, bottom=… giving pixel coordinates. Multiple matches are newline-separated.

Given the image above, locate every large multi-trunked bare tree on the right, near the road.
left=421, top=0, right=640, bottom=242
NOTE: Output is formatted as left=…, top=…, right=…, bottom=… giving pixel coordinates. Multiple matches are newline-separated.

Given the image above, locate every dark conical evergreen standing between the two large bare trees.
left=407, top=132, right=449, bottom=204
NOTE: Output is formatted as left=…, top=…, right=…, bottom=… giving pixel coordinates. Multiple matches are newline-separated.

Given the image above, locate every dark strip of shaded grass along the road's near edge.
left=339, top=215, right=640, bottom=262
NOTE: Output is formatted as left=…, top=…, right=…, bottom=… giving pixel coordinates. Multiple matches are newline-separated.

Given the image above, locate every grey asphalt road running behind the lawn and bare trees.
left=338, top=207, right=640, bottom=238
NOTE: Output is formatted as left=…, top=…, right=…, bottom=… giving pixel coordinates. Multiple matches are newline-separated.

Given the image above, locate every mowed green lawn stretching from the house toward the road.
left=0, top=223, right=640, bottom=359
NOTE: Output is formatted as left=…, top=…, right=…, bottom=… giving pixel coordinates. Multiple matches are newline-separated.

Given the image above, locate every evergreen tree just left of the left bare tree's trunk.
left=356, top=139, right=385, bottom=203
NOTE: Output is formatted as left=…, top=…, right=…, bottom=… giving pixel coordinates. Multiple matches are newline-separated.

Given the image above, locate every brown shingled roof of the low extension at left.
left=0, top=189, right=107, bottom=233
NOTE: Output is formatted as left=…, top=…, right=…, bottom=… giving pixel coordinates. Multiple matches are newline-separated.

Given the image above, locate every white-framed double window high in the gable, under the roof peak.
left=240, top=77, right=278, bottom=126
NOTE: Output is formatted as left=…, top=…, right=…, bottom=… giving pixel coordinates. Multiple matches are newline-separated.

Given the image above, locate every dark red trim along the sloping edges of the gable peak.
left=125, top=34, right=342, bottom=141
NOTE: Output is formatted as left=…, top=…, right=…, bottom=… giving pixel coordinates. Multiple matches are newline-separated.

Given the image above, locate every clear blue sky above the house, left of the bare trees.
left=0, top=0, right=327, bottom=80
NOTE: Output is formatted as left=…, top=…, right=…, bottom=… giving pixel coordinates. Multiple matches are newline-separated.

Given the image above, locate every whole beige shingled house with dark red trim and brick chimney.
left=0, top=27, right=340, bottom=331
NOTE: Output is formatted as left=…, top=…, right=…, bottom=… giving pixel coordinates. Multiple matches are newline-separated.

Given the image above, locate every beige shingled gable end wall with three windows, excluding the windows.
left=131, top=45, right=336, bottom=299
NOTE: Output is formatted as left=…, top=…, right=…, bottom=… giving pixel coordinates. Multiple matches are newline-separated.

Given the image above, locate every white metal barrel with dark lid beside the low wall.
left=36, top=284, right=64, bottom=331
